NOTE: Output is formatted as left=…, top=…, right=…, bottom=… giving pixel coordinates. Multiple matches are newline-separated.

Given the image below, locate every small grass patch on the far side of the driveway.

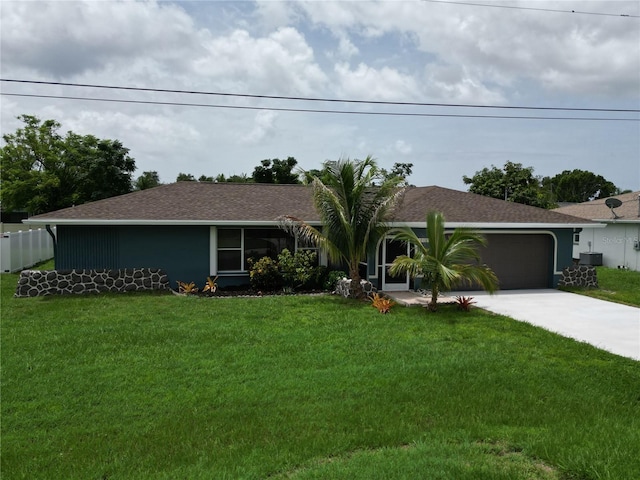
left=563, top=267, right=640, bottom=307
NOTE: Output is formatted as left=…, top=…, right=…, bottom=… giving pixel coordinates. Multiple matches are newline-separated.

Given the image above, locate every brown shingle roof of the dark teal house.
left=29, top=182, right=585, bottom=224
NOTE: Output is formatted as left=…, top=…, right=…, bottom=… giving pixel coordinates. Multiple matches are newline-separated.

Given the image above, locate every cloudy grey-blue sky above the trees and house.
left=0, top=0, right=640, bottom=190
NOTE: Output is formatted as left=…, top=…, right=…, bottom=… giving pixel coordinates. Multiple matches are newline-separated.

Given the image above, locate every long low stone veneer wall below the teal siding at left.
left=15, top=268, right=169, bottom=297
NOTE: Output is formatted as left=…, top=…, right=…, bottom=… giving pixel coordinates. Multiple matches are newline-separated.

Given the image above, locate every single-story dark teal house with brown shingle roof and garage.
left=26, top=182, right=591, bottom=291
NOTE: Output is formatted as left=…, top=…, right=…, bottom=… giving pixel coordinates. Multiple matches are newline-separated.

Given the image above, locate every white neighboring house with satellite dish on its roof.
left=555, top=191, right=640, bottom=271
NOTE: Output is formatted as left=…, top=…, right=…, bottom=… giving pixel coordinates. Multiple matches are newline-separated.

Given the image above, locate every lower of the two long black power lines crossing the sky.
left=0, top=92, right=640, bottom=122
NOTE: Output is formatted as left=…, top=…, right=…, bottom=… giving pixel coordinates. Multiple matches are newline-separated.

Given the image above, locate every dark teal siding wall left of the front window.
left=55, top=225, right=210, bottom=287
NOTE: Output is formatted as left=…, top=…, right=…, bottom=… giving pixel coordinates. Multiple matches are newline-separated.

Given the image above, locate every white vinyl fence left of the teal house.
left=0, top=227, right=56, bottom=273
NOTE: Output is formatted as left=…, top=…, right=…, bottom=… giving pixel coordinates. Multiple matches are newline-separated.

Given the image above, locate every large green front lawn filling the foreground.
left=0, top=275, right=640, bottom=480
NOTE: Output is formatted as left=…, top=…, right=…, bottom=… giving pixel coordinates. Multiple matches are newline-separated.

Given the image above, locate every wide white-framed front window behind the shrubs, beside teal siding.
left=217, top=228, right=295, bottom=272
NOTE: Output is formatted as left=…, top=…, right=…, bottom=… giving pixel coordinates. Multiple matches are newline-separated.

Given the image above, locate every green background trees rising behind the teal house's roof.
left=0, top=115, right=624, bottom=214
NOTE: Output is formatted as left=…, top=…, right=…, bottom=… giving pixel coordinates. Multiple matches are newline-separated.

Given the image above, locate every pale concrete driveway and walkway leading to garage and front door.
left=388, top=289, right=640, bottom=360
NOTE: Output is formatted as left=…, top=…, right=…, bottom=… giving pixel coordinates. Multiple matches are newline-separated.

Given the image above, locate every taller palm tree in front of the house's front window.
left=280, top=156, right=404, bottom=298
